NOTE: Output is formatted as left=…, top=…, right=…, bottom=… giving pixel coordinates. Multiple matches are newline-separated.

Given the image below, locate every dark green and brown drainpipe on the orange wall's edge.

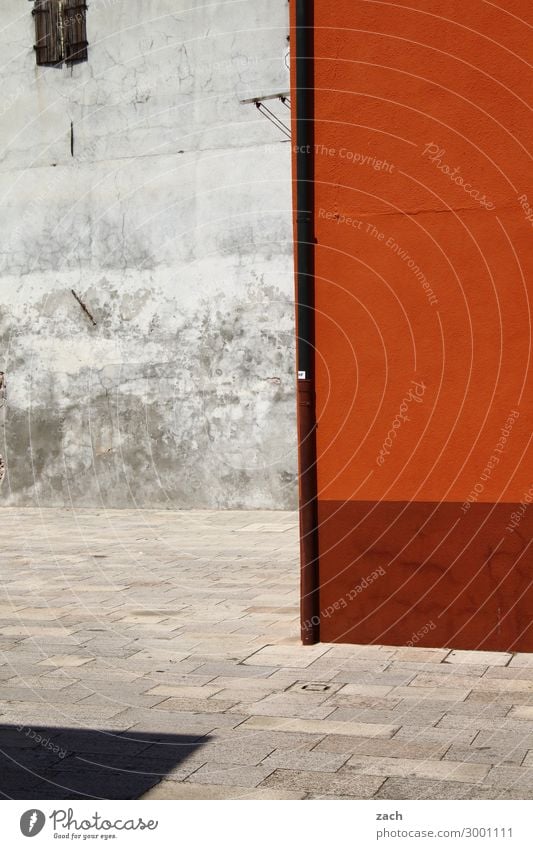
left=296, top=0, right=320, bottom=645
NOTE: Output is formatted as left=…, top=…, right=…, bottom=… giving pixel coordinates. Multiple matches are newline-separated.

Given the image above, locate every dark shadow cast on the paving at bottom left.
left=0, top=725, right=208, bottom=799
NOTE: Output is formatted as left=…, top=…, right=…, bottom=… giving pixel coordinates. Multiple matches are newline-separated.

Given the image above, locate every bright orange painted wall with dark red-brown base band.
left=292, top=0, right=533, bottom=650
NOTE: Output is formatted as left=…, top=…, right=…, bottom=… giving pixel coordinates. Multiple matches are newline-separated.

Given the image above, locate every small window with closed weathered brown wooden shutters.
left=32, top=0, right=87, bottom=67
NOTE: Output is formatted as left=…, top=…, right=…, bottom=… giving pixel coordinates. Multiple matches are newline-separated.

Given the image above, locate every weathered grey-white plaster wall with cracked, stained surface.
left=0, top=0, right=296, bottom=508
